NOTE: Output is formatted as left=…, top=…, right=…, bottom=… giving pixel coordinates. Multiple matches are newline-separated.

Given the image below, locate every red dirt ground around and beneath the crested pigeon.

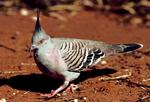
left=0, top=11, right=150, bottom=102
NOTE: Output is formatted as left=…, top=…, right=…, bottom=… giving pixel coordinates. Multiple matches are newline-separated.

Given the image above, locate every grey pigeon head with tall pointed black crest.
left=30, top=11, right=50, bottom=51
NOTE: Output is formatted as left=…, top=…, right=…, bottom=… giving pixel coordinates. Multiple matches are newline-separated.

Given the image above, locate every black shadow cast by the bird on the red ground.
left=0, top=68, right=116, bottom=93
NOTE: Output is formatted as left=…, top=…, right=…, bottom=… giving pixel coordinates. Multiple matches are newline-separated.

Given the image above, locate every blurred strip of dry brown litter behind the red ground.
left=0, top=0, right=150, bottom=27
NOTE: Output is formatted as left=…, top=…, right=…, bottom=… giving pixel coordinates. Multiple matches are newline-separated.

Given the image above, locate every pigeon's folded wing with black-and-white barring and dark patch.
left=54, top=39, right=105, bottom=72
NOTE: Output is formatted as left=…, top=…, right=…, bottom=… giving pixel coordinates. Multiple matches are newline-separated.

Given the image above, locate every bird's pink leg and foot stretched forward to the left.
left=41, top=81, right=69, bottom=98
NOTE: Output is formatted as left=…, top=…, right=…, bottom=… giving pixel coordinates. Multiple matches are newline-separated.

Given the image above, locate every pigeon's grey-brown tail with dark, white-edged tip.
left=108, top=43, right=143, bottom=55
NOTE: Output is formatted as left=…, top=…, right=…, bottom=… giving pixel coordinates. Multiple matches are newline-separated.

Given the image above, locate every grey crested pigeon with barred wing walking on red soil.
left=30, top=11, right=143, bottom=98
